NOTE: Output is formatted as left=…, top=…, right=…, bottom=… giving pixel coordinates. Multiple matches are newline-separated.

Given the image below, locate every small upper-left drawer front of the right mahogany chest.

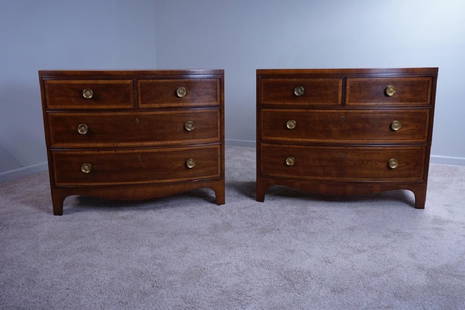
left=260, top=78, right=342, bottom=106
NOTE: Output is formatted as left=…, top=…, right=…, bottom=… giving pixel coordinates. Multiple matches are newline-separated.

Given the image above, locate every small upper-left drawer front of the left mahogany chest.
left=45, top=80, right=134, bottom=109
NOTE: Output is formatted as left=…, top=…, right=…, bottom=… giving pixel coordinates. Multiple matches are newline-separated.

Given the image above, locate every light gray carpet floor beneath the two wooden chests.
left=0, top=147, right=465, bottom=309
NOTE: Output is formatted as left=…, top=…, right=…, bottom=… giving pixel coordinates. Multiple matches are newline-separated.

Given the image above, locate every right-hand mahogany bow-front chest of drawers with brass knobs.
left=256, top=68, right=438, bottom=208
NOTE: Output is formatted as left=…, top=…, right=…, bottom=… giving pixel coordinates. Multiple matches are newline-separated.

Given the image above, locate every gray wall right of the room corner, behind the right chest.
left=156, top=0, right=465, bottom=164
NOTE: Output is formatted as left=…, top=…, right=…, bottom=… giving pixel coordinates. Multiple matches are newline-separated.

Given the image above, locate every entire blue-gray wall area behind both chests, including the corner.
left=0, top=0, right=465, bottom=179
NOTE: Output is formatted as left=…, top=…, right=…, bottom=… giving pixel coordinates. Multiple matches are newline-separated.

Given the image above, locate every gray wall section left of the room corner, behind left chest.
left=0, top=0, right=155, bottom=176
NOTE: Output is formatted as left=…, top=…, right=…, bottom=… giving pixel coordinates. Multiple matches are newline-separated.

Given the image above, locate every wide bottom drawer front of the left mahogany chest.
left=52, top=145, right=220, bottom=186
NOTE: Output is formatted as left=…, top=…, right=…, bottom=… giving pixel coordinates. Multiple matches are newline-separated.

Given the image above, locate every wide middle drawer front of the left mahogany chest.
left=47, top=110, right=220, bottom=147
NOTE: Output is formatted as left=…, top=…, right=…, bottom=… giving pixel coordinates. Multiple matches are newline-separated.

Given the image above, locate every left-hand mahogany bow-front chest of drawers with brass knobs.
left=39, top=70, right=224, bottom=215
